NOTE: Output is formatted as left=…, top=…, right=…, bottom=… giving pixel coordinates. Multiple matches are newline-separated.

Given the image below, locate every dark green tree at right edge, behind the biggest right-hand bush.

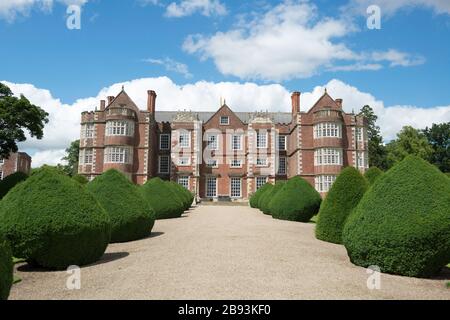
left=423, top=122, right=450, bottom=172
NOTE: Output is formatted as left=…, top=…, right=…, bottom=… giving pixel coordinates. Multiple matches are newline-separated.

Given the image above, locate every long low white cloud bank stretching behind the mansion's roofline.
left=2, top=77, right=450, bottom=166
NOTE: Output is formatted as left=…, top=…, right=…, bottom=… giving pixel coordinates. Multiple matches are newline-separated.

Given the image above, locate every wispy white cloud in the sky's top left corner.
left=0, top=0, right=88, bottom=22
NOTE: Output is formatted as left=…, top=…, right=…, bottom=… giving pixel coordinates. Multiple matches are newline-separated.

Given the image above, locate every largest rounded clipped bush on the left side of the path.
left=0, top=168, right=111, bottom=269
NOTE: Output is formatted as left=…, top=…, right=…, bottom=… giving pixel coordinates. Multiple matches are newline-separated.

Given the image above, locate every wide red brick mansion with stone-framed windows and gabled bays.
left=79, top=90, right=368, bottom=201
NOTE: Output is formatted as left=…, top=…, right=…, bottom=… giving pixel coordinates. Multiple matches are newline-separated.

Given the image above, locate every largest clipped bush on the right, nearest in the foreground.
left=343, top=156, right=450, bottom=277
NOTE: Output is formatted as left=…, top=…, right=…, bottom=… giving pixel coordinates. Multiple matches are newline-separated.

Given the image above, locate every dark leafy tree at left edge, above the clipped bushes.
left=0, top=83, right=48, bottom=158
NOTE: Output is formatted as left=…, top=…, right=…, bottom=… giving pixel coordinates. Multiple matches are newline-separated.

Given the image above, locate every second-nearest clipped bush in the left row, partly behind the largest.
left=87, top=169, right=155, bottom=242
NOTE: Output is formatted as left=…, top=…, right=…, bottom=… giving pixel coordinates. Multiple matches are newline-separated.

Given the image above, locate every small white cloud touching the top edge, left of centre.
left=165, top=0, right=228, bottom=18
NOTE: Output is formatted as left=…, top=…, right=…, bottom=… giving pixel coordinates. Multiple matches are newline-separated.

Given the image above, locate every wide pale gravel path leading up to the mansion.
left=10, top=206, right=450, bottom=299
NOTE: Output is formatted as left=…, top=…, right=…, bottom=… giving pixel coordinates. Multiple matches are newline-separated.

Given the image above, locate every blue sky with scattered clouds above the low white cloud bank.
left=0, top=0, right=450, bottom=165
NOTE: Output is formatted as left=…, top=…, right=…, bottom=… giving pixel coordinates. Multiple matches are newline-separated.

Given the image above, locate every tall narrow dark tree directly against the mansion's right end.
left=359, top=105, right=387, bottom=169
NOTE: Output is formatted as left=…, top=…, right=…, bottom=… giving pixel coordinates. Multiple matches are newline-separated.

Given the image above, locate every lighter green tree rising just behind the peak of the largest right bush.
left=386, top=126, right=433, bottom=167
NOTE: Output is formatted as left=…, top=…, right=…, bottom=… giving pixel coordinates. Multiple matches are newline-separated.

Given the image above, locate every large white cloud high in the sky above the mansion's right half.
left=183, top=0, right=424, bottom=81
